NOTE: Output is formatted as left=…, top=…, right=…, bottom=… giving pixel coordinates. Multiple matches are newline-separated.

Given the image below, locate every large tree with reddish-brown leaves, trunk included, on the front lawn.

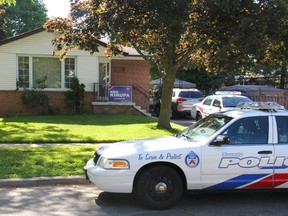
left=45, top=0, right=286, bottom=129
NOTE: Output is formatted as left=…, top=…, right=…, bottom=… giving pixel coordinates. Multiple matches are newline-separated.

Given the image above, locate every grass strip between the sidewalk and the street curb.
left=0, top=145, right=97, bottom=179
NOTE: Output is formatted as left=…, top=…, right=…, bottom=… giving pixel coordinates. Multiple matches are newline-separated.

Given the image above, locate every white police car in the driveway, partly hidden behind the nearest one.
left=190, top=91, right=252, bottom=121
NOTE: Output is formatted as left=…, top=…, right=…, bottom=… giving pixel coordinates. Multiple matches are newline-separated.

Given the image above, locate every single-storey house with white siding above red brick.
left=0, top=28, right=150, bottom=116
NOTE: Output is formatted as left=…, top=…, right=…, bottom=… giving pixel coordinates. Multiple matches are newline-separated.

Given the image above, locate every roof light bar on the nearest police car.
left=237, top=102, right=285, bottom=111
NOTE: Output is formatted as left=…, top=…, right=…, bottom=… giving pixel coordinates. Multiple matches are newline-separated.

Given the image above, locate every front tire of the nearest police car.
left=136, top=165, right=183, bottom=210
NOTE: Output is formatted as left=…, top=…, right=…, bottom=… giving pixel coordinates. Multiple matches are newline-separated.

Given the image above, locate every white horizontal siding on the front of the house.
left=0, top=31, right=109, bottom=91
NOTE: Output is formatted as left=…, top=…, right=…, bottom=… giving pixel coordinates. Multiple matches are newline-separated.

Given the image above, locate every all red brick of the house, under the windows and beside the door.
left=0, top=60, right=150, bottom=116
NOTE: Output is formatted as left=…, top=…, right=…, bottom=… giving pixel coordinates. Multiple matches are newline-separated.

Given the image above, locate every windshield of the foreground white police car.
left=177, top=114, right=232, bottom=142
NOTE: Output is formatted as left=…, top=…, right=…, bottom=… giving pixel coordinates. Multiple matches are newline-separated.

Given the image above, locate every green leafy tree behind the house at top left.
left=2, top=0, right=48, bottom=37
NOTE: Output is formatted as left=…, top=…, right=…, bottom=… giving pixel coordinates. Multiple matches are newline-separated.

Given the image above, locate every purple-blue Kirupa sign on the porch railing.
left=108, top=86, right=132, bottom=103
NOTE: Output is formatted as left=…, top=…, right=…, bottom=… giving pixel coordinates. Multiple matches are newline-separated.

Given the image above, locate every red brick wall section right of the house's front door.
left=111, top=60, right=150, bottom=111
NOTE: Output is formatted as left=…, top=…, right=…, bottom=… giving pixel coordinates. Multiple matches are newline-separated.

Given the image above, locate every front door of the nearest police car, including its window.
left=201, top=116, right=275, bottom=189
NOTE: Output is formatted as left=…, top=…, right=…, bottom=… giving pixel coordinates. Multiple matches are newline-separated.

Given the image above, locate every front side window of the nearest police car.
left=222, top=116, right=268, bottom=145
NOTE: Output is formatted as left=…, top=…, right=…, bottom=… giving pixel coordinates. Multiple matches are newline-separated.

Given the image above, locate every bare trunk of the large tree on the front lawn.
left=157, top=65, right=177, bottom=129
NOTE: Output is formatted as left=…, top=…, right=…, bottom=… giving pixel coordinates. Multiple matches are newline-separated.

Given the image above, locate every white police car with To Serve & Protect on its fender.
left=84, top=103, right=288, bottom=209
